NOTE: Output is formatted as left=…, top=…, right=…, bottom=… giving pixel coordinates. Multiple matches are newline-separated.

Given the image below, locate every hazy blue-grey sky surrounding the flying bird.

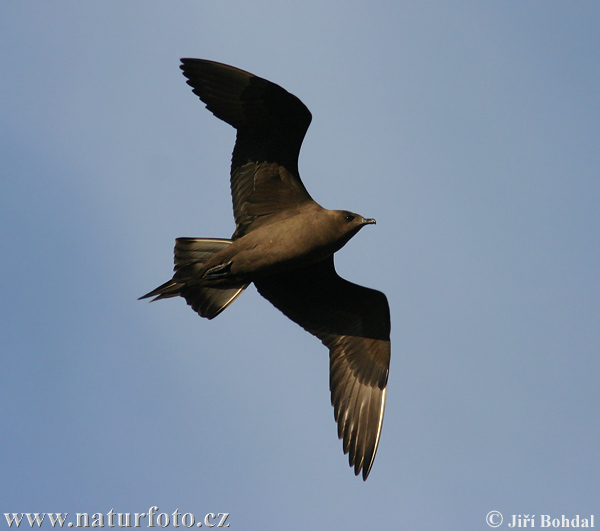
left=0, top=0, right=600, bottom=530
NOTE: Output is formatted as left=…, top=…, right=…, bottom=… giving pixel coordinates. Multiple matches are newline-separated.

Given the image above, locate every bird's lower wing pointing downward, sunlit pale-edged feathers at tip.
left=255, top=257, right=390, bottom=479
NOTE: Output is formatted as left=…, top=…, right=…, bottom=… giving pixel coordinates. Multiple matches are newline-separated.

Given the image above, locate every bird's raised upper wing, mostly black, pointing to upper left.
left=181, top=59, right=312, bottom=239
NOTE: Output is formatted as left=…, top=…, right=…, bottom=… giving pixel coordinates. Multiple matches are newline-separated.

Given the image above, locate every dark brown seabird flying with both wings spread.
left=140, top=58, right=391, bottom=480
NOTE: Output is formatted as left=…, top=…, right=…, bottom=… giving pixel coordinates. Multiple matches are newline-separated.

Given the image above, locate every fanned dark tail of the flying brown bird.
left=140, top=238, right=248, bottom=319
